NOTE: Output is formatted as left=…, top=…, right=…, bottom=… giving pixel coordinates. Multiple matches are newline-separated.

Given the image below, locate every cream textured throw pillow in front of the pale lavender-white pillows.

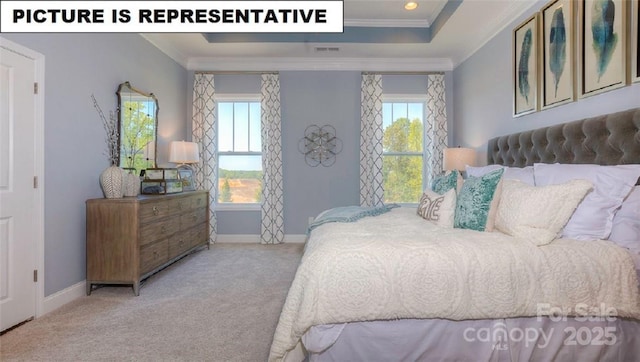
left=495, top=180, right=593, bottom=245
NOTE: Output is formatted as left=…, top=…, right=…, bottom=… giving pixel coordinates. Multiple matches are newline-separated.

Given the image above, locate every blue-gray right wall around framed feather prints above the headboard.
left=450, top=1, right=640, bottom=164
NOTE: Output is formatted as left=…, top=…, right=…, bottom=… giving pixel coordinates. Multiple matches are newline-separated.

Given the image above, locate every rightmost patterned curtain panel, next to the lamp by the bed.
left=425, top=74, right=447, bottom=185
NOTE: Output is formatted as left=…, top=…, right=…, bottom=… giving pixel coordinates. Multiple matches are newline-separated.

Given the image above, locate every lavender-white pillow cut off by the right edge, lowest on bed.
left=609, top=186, right=640, bottom=254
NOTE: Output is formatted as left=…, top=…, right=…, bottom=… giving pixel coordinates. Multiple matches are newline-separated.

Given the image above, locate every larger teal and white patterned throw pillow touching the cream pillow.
left=453, top=169, right=504, bottom=231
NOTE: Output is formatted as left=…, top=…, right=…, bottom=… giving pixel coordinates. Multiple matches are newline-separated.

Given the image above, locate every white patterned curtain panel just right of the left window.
left=260, top=74, right=284, bottom=244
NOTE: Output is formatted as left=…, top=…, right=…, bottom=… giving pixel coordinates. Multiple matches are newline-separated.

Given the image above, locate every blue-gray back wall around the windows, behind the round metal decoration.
left=189, top=71, right=453, bottom=235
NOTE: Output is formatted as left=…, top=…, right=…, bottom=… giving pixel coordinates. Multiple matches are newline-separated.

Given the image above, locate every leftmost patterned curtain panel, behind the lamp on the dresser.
left=192, top=73, right=218, bottom=242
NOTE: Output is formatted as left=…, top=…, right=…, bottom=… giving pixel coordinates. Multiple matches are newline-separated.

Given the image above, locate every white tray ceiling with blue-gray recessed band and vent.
left=142, top=0, right=536, bottom=71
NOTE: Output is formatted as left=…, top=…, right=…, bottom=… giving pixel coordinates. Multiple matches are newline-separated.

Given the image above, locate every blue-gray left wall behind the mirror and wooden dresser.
left=2, top=34, right=188, bottom=296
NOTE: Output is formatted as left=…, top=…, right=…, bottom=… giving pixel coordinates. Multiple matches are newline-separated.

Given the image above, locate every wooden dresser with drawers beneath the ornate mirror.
left=87, top=191, right=209, bottom=295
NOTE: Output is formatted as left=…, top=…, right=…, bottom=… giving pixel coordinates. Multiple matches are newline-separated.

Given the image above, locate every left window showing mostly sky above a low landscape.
left=217, top=97, right=262, bottom=205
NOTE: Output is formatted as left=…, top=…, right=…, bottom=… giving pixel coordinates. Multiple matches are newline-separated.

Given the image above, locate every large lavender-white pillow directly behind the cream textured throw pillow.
left=533, top=163, right=640, bottom=240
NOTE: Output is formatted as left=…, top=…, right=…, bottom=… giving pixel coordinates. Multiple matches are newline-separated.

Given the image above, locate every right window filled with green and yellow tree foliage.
left=382, top=97, right=425, bottom=203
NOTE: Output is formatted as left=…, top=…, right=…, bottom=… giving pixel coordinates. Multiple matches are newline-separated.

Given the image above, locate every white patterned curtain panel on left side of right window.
left=360, top=74, right=384, bottom=207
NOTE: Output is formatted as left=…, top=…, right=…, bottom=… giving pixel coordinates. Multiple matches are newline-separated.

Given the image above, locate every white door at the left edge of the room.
left=0, top=41, right=37, bottom=330
